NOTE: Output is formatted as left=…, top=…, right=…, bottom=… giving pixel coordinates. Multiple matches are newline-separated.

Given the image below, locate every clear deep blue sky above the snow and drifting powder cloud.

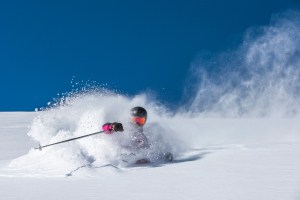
left=0, top=0, right=300, bottom=111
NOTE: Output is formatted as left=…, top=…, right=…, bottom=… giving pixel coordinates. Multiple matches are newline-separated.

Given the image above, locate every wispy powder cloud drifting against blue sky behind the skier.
left=188, top=11, right=300, bottom=118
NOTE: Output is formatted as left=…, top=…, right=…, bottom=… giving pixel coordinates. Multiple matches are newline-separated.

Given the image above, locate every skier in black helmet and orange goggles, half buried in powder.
left=102, top=106, right=173, bottom=164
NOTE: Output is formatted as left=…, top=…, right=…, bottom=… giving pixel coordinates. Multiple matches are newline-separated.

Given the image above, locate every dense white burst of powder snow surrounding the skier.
left=9, top=89, right=185, bottom=176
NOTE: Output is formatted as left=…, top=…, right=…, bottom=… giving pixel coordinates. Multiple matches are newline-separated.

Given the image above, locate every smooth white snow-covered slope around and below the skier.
left=0, top=113, right=300, bottom=200
